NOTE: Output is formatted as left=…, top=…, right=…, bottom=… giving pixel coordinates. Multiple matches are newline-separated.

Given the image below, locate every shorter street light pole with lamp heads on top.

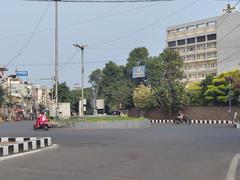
left=73, top=43, right=87, bottom=116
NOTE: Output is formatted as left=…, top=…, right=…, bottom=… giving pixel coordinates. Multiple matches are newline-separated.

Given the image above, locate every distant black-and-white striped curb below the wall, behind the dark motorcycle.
left=150, top=119, right=234, bottom=124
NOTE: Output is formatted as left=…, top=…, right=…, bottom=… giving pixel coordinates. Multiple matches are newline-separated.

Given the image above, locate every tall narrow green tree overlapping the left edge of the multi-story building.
left=156, top=49, right=185, bottom=118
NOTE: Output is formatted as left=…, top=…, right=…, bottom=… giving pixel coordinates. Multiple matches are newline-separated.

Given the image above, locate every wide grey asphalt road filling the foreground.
left=0, top=122, right=240, bottom=180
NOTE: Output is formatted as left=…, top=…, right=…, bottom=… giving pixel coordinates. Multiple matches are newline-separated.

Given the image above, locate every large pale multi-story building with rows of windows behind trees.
left=166, top=12, right=240, bottom=81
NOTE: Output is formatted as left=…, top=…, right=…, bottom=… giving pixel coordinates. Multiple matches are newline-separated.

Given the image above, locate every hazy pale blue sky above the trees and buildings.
left=0, top=0, right=236, bottom=87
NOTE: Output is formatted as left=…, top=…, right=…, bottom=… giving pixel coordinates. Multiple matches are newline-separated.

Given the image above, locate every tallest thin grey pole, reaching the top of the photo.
left=54, top=1, right=59, bottom=119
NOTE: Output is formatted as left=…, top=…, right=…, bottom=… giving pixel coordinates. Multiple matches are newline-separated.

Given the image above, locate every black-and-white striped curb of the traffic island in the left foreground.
left=0, top=137, right=52, bottom=157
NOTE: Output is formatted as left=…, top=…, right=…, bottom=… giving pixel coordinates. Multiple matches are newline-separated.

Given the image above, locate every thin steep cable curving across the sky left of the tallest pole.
left=5, top=3, right=50, bottom=68
